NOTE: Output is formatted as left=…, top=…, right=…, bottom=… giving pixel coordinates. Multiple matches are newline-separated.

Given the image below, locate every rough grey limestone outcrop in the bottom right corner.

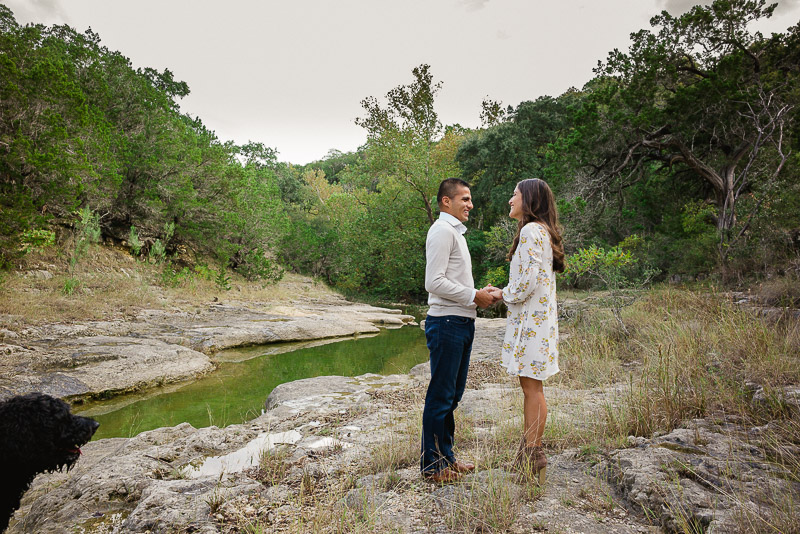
left=601, top=420, right=800, bottom=533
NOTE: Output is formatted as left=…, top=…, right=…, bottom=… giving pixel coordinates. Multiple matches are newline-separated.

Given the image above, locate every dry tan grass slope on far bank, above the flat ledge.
left=0, top=246, right=338, bottom=326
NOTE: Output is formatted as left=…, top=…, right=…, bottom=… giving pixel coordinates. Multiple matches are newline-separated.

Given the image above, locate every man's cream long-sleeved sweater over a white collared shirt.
left=425, top=214, right=476, bottom=318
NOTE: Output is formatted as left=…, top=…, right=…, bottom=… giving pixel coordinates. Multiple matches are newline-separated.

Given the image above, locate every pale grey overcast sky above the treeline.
left=0, top=0, right=800, bottom=163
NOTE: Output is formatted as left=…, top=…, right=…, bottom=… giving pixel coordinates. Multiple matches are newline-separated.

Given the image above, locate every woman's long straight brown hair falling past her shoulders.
left=507, top=178, right=565, bottom=273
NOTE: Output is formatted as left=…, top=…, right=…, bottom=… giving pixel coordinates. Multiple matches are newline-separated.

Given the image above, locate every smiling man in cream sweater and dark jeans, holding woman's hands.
left=420, top=178, right=495, bottom=483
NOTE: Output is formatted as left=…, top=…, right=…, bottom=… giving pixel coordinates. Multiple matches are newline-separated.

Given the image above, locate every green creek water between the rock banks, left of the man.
left=75, top=326, right=428, bottom=439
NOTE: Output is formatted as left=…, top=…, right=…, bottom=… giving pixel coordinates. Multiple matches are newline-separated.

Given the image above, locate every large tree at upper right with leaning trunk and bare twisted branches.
left=576, top=0, right=797, bottom=262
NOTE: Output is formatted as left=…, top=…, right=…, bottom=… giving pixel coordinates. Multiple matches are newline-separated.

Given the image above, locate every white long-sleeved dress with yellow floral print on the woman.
left=501, top=222, right=558, bottom=380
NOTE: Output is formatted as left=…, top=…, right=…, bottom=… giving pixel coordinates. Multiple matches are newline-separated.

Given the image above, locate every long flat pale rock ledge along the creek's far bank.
left=0, top=299, right=414, bottom=401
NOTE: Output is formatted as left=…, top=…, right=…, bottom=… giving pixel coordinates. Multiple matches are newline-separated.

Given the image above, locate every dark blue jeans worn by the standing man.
left=420, top=315, right=475, bottom=473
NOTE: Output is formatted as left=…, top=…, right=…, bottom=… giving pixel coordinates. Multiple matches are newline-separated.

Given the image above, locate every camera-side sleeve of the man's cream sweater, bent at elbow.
left=425, top=227, right=475, bottom=306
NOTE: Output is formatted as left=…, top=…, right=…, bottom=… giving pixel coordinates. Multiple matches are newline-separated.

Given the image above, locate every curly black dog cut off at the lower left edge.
left=0, top=393, right=100, bottom=532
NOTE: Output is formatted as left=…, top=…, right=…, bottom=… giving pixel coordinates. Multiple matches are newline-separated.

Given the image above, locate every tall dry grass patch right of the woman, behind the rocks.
left=557, top=288, right=800, bottom=444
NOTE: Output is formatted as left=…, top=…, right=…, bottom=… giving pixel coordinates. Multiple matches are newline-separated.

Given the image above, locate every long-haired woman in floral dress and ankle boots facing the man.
left=488, top=179, right=564, bottom=484
